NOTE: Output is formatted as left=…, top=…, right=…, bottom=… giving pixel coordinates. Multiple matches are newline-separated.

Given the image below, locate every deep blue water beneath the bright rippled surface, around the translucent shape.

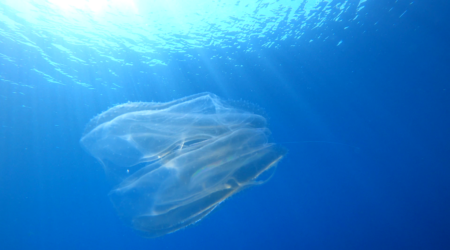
left=0, top=1, right=450, bottom=249
